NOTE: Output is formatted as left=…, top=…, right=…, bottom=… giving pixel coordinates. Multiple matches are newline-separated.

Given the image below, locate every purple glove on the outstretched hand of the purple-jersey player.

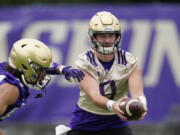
left=61, top=66, right=85, bottom=82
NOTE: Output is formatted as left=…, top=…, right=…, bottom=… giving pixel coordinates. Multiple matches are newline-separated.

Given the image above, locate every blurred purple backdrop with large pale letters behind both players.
left=0, top=0, right=180, bottom=135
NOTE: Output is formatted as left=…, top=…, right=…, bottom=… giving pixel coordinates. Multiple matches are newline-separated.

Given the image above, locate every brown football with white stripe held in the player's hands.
left=119, top=98, right=145, bottom=120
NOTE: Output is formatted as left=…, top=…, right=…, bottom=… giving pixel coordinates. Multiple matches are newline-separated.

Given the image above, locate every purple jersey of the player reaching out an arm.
left=0, top=62, right=29, bottom=121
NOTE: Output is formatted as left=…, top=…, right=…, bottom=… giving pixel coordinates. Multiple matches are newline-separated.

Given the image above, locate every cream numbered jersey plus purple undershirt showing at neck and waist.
left=70, top=49, right=137, bottom=131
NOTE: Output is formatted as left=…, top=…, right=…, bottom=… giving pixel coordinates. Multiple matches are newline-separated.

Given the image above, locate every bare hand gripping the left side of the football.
left=113, top=97, right=128, bottom=121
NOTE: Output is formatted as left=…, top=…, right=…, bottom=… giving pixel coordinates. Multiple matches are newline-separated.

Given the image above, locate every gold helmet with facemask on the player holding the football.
left=88, top=11, right=121, bottom=55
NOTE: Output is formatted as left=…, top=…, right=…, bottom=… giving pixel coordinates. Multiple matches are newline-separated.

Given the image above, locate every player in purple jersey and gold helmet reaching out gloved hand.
left=0, top=39, right=84, bottom=134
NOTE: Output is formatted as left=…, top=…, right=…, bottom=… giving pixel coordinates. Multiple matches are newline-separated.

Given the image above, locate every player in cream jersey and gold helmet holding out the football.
left=62, top=11, right=147, bottom=135
